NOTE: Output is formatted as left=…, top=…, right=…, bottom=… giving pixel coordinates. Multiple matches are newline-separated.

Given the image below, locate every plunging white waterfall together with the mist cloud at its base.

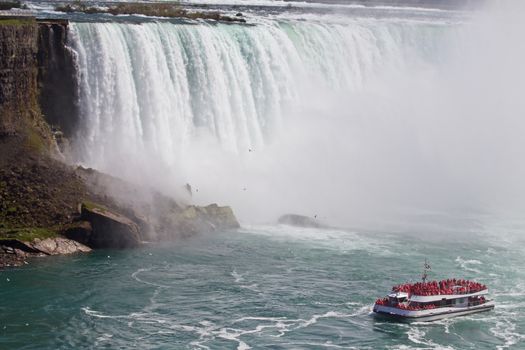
left=71, top=2, right=525, bottom=228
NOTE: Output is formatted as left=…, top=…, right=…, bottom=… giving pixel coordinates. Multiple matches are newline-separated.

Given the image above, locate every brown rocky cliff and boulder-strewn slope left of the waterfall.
left=0, top=17, right=239, bottom=267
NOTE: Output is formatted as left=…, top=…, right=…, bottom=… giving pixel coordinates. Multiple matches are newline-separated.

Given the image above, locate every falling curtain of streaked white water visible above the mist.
left=71, top=22, right=446, bottom=169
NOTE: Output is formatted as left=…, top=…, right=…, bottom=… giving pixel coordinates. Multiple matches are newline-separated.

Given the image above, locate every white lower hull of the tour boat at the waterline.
left=373, top=302, right=494, bottom=322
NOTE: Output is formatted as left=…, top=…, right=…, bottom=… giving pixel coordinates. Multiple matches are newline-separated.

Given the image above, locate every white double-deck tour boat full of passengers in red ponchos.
left=373, top=262, right=494, bottom=321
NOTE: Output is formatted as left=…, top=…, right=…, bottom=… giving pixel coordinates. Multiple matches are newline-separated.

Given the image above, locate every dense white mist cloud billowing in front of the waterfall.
left=71, top=1, right=525, bottom=234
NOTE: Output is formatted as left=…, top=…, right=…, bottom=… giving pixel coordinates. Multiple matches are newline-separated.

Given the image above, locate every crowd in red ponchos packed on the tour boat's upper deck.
left=392, top=278, right=487, bottom=296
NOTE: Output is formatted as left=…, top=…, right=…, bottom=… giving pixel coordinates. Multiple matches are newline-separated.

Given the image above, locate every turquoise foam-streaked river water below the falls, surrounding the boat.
left=0, top=226, right=525, bottom=349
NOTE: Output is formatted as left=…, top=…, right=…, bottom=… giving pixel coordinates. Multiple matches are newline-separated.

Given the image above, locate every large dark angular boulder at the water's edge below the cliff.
left=81, top=203, right=141, bottom=249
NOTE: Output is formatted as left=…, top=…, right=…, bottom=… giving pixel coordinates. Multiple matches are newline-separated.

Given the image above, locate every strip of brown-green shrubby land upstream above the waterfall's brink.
left=55, top=1, right=246, bottom=23
